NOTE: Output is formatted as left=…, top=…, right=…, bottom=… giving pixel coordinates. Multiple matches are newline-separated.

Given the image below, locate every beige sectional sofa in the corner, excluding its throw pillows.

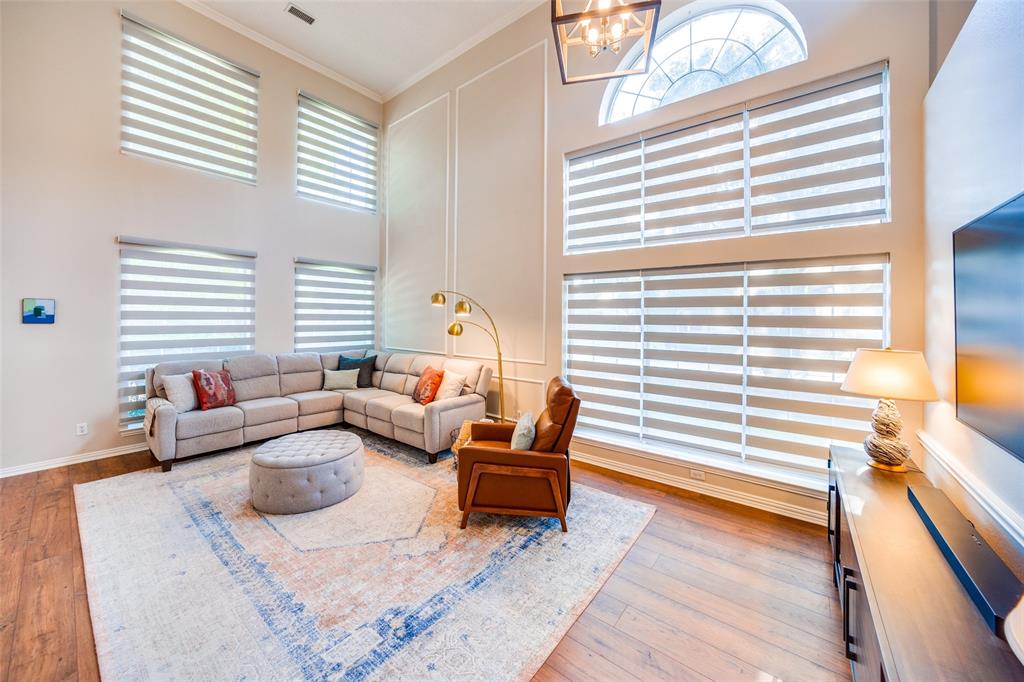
left=143, top=350, right=492, bottom=471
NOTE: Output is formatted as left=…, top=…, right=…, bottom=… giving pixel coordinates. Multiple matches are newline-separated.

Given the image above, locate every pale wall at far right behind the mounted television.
left=924, top=0, right=1024, bottom=570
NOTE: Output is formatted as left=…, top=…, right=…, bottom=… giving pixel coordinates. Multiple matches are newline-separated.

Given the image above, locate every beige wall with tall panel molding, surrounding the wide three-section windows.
left=384, top=0, right=929, bottom=516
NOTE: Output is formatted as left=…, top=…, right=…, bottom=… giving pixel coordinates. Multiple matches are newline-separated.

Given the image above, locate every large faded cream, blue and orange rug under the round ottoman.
left=75, top=431, right=653, bottom=681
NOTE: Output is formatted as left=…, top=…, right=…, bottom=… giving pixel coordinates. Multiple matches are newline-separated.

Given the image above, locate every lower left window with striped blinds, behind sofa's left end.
left=119, top=238, right=256, bottom=430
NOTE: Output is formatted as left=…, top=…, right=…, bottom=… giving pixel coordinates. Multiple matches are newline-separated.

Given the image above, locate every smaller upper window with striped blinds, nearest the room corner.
left=296, top=92, right=377, bottom=211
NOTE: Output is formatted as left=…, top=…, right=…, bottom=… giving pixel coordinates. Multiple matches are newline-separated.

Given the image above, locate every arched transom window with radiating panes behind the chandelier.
left=601, top=5, right=807, bottom=124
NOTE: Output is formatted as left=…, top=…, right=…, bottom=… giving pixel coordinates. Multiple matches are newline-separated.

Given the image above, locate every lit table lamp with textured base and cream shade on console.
left=842, top=348, right=939, bottom=472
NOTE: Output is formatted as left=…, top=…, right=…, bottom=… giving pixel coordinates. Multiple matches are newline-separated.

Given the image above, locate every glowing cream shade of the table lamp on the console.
left=843, top=348, right=939, bottom=400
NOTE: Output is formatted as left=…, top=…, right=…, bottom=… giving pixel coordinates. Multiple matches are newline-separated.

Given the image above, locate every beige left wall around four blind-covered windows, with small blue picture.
left=0, top=1, right=381, bottom=469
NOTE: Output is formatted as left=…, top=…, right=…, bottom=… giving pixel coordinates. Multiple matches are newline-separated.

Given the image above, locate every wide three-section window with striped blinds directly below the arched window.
left=565, top=65, right=889, bottom=253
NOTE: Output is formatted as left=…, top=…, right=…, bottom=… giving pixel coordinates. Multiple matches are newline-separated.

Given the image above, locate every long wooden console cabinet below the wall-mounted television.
left=827, top=445, right=1024, bottom=682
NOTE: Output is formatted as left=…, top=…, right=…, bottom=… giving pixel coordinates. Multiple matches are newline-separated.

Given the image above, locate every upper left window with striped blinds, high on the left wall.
left=121, top=15, right=259, bottom=182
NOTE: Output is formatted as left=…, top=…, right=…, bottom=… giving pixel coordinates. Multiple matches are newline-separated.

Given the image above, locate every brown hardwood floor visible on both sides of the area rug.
left=0, top=453, right=850, bottom=682
